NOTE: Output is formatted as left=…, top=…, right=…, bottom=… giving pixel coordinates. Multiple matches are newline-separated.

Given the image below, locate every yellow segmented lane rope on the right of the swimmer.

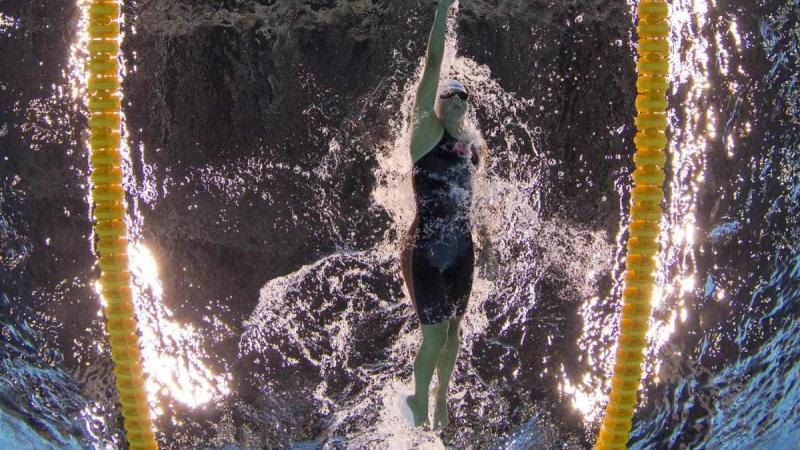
left=595, top=0, right=669, bottom=450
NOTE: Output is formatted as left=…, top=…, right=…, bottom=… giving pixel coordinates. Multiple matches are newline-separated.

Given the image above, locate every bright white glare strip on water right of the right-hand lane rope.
left=644, top=0, right=715, bottom=377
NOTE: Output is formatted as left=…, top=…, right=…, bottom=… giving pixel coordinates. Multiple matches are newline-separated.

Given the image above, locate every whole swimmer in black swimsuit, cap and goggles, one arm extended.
left=401, top=0, right=496, bottom=429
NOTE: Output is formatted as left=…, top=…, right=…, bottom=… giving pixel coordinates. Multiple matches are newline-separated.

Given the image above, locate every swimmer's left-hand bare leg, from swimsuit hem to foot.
left=406, top=321, right=449, bottom=426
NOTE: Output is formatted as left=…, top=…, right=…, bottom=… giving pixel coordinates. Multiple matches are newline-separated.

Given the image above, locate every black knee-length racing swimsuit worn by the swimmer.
left=411, top=131, right=477, bottom=324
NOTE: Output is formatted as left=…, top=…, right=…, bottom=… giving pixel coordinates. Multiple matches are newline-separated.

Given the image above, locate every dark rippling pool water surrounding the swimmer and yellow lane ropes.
left=0, top=0, right=800, bottom=449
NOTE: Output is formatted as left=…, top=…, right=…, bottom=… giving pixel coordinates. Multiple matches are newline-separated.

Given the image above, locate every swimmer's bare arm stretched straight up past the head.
left=411, top=0, right=455, bottom=160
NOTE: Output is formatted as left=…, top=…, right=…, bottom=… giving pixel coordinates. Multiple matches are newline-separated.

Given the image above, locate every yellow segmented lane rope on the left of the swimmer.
left=87, top=0, right=158, bottom=450
